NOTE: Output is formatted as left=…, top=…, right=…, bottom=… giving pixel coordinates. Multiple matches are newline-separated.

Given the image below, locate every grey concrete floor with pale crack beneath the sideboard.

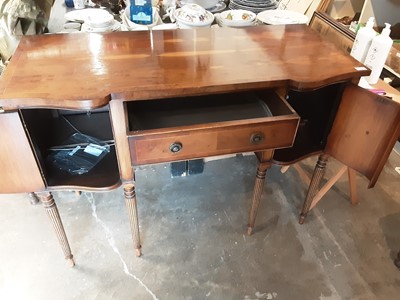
left=0, top=146, right=400, bottom=300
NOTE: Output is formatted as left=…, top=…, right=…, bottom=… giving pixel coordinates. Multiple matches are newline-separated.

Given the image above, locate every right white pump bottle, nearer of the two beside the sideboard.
left=364, top=23, right=393, bottom=84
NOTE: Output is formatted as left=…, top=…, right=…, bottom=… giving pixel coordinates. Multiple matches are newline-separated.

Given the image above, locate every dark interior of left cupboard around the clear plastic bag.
left=20, top=109, right=120, bottom=189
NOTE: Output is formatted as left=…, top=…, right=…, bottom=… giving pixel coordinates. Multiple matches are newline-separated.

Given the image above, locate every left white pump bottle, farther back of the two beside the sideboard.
left=350, top=17, right=377, bottom=62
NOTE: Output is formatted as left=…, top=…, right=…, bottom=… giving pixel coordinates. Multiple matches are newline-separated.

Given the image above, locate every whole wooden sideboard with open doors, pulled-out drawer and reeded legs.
left=0, top=25, right=400, bottom=264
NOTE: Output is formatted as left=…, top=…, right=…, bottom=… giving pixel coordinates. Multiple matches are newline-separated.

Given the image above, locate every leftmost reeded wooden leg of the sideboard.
left=36, top=192, right=75, bottom=267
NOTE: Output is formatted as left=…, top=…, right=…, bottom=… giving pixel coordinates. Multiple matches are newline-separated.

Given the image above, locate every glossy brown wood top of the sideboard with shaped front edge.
left=0, top=25, right=369, bottom=109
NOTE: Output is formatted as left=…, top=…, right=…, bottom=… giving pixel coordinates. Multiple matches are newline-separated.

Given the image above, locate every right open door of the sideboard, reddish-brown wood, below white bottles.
left=325, top=84, right=400, bottom=188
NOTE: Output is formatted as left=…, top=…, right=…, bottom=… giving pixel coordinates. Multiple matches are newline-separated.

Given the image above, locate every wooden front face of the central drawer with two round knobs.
left=129, top=116, right=298, bottom=165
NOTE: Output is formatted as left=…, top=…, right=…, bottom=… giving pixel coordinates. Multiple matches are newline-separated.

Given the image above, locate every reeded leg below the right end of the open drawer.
left=247, top=163, right=271, bottom=235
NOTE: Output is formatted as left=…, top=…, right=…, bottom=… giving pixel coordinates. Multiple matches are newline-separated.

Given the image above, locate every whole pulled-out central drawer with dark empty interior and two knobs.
left=127, top=91, right=299, bottom=165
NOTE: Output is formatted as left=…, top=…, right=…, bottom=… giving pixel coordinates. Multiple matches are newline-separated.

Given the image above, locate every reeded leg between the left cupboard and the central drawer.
left=124, top=184, right=142, bottom=256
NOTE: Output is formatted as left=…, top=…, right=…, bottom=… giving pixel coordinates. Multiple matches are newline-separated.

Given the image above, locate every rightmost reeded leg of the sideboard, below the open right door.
left=299, top=154, right=329, bottom=224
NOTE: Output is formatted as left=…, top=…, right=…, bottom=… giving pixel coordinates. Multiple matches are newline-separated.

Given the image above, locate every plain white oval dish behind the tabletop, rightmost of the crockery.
left=257, top=9, right=308, bottom=25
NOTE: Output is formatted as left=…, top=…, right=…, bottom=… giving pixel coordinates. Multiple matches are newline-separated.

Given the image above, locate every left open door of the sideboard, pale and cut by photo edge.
left=0, top=112, right=45, bottom=194
